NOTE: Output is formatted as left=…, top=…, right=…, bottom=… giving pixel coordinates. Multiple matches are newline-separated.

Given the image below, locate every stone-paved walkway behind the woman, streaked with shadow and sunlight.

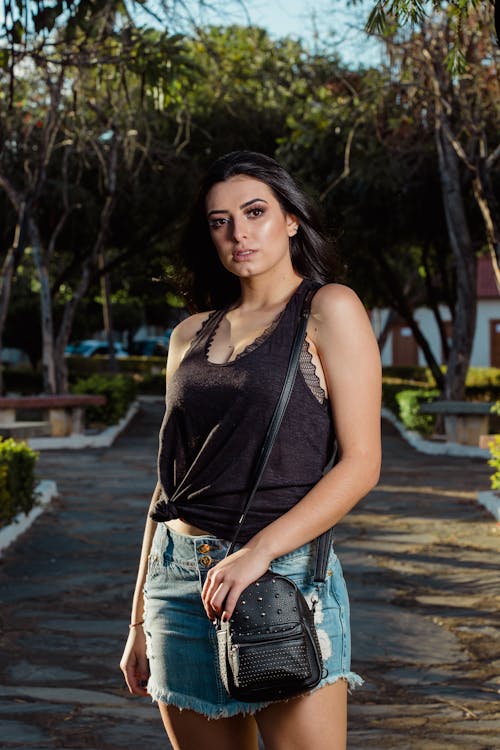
left=0, top=404, right=500, bottom=750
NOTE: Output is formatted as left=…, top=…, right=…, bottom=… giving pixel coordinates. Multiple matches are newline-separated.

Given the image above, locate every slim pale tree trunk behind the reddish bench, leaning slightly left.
left=28, top=216, right=57, bottom=393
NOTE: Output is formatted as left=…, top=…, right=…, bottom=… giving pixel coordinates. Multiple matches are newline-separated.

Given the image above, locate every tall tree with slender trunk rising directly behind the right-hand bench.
left=380, top=6, right=500, bottom=399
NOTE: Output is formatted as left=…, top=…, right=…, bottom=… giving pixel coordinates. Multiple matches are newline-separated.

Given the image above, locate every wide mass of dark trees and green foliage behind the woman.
left=0, top=0, right=500, bottom=397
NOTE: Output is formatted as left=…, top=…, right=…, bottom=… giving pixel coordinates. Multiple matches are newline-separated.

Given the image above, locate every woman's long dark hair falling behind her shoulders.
left=181, top=151, right=334, bottom=310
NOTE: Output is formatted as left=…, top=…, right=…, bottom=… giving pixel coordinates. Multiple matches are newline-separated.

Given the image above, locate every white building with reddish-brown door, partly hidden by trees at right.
left=371, top=256, right=500, bottom=367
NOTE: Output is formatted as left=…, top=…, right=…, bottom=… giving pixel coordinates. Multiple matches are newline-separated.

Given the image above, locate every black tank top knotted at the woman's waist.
left=152, top=279, right=335, bottom=542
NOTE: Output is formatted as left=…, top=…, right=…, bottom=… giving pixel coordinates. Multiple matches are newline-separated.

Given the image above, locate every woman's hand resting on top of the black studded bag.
left=201, top=547, right=271, bottom=620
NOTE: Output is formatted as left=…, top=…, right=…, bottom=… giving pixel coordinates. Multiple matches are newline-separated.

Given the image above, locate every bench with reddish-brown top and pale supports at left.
left=0, top=394, right=106, bottom=438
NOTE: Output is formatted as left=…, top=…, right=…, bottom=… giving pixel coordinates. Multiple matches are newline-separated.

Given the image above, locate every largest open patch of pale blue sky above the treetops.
left=188, top=0, right=381, bottom=65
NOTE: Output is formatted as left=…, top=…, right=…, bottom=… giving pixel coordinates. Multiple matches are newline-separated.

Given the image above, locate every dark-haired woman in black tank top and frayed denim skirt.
left=121, top=151, right=380, bottom=750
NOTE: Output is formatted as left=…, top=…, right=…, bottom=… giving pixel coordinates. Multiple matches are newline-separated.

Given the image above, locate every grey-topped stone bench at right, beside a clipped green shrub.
left=420, top=401, right=493, bottom=445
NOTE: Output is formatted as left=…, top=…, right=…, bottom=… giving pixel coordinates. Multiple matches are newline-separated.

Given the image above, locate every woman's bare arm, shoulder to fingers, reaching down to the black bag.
left=203, top=284, right=381, bottom=618
